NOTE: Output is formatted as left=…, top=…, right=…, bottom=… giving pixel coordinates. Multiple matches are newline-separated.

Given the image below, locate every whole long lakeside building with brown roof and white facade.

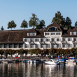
left=0, top=23, right=77, bottom=50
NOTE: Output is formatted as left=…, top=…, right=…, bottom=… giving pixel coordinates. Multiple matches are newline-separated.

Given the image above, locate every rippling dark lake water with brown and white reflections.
left=0, top=63, right=77, bottom=77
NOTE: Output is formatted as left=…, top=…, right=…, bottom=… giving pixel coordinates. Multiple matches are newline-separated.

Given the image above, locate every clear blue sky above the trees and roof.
left=0, top=0, right=77, bottom=30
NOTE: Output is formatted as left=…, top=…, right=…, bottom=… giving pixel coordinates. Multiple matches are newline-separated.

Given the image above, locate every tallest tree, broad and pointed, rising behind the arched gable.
left=52, top=11, right=65, bottom=26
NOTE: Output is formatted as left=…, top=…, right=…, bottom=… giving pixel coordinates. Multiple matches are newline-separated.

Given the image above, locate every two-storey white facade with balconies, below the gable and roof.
left=24, top=36, right=77, bottom=49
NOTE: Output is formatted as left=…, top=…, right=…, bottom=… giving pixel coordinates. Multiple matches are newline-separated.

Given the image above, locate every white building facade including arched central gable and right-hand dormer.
left=23, top=26, right=77, bottom=49
